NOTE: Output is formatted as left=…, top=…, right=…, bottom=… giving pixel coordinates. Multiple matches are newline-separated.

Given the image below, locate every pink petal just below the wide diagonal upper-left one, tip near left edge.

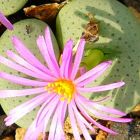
left=7, top=50, right=56, bottom=81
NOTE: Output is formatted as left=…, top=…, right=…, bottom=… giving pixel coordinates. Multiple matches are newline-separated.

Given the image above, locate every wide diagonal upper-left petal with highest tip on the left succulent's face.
left=12, top=37, right=48, bottom=73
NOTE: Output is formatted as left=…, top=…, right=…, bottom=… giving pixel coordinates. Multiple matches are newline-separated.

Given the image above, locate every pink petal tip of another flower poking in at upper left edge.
left=0, top=12, right=13, bottom=30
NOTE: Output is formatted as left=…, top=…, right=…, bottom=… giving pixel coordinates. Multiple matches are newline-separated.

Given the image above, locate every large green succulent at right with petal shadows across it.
left=56, top=0, right=140, bottom=112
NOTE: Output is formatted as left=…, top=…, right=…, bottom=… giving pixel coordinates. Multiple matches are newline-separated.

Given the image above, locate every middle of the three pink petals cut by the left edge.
left=0, top=72, right=48, bottom=87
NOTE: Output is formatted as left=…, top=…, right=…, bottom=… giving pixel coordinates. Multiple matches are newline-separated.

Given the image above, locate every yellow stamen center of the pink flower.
left=45, top=79, right=75, bottom=103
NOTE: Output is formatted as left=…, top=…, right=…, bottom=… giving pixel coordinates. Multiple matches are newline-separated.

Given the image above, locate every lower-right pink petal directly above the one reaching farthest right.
left=78, top=95, right=126, bottom=116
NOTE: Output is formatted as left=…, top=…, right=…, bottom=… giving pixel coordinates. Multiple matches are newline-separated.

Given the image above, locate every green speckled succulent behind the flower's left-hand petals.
left=0, top=19, right=59, bottom=128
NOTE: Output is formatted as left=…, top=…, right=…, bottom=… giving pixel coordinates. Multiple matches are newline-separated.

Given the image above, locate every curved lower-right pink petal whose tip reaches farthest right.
left=77, top=96, right=132, bottom=122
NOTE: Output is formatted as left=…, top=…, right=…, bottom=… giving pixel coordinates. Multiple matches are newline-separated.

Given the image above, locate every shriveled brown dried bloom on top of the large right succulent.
left=82, top=13, right=99, bottom=42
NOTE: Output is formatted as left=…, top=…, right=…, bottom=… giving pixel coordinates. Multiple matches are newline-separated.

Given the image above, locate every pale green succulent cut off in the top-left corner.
left=0, top=0, right=28, bottom=16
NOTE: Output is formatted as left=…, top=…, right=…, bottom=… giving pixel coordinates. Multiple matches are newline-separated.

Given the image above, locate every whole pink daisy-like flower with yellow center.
left=0, top=28, right=131, bottom=140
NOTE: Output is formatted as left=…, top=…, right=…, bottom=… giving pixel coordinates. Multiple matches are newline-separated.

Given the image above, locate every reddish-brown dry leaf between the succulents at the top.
left=24, top=2, right=66, bottom=22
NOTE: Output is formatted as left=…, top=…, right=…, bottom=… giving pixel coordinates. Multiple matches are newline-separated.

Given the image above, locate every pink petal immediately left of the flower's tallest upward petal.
left=37, top=36, right=59, bottom=77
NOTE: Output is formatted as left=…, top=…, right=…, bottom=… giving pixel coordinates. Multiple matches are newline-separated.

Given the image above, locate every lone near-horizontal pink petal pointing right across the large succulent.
left=77, top=82, right=125, bottom=93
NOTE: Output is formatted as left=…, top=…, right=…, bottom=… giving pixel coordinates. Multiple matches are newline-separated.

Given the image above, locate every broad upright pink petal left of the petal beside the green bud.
left=60, top=40, right=73, bottom=78
